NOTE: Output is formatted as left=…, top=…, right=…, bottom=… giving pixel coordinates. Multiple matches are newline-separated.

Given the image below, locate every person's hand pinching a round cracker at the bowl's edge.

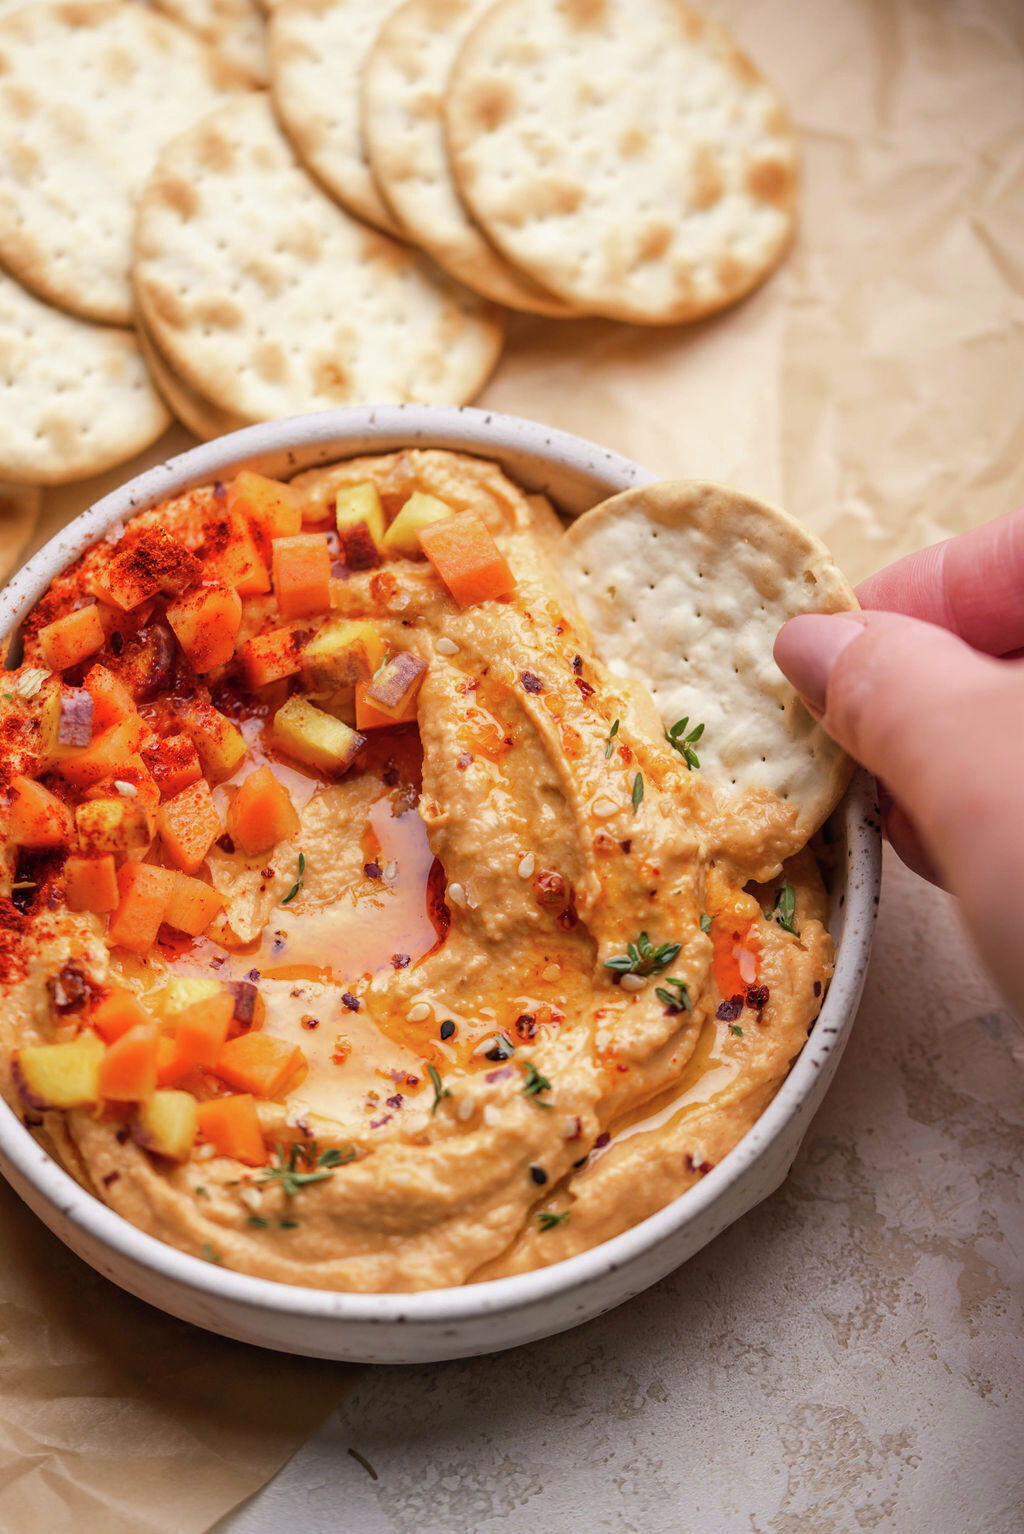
left=776, top=509, right=1024, bottom=1006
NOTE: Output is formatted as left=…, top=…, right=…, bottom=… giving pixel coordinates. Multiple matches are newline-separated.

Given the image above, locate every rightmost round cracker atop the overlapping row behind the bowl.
left=448, top=0, right=797, bottom=324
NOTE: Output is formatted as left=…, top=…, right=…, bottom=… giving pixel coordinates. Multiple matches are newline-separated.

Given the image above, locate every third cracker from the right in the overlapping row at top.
left=270, top=0, right=399, bottom=235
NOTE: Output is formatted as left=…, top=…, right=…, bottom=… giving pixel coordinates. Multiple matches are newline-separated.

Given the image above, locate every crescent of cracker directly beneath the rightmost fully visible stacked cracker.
left=363, top=0, right=578, bottom=318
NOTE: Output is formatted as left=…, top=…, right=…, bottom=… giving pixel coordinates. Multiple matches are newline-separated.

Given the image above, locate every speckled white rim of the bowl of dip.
left=0, top=405, right=881, bottom=1325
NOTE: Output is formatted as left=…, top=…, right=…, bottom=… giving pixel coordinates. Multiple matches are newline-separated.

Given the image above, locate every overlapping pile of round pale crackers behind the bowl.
left=0, top=0, right=796, bottom=503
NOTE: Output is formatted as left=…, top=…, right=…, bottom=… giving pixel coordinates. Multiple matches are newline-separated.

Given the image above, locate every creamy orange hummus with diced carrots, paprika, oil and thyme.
left=0, top=451, right=832, bottom=1292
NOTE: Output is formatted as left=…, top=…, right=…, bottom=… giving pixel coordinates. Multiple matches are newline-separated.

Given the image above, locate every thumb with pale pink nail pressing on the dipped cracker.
left=776, top=612, right=1024, bottom=994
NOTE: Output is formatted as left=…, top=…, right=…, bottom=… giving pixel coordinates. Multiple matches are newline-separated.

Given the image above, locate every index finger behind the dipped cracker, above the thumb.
left=857, top=508, right=1024, bottom=655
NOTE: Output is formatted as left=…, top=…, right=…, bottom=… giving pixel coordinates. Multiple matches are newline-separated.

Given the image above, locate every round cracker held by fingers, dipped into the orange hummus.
left=558, top=480, right=858, bottom=850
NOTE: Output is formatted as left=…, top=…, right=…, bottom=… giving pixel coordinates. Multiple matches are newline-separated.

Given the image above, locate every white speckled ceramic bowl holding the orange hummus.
left=0, top=405, right=881, bottom=1364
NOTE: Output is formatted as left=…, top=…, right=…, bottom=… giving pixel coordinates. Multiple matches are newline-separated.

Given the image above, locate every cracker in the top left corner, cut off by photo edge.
left=0, top=0, right=233, bottom=325
